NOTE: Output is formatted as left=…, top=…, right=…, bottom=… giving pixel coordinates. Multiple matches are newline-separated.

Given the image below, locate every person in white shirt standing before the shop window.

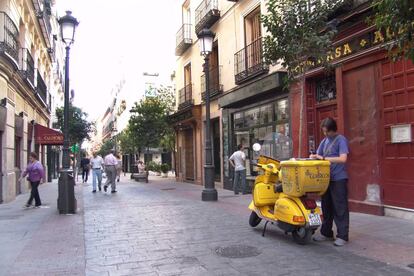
left=229, top=145, right=247, bottom=195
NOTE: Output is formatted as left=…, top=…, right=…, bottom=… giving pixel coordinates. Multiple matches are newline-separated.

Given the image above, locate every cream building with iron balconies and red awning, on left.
left=0, top=0, right=64, bottom=203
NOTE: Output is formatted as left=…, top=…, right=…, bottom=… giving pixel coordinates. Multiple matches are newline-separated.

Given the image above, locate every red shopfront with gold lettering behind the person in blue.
left=290, top=1, right=414, bottom=215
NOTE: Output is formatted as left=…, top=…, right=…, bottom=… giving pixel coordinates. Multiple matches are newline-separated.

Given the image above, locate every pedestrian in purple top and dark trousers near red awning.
left=19, top=152, right=45, bottom=207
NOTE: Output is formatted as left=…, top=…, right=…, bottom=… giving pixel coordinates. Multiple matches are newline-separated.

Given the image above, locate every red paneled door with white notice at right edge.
left=379, top=61, right=414, bottom=209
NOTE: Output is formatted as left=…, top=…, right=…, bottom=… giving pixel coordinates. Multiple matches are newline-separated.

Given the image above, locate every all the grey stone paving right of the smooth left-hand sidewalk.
left=83, top=177, right=414, bottom=276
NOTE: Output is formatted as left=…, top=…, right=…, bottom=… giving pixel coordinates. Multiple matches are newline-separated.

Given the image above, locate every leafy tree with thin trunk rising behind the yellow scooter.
left=262, top=0, right=345, bottom=156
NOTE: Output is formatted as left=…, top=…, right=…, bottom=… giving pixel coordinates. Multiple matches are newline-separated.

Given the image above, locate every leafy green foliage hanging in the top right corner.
left=371, top=0, right=414, bottom=62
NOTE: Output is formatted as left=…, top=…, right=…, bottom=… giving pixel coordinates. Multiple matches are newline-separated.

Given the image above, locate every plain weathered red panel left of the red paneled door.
left=342, top=64, right=380, bottom=203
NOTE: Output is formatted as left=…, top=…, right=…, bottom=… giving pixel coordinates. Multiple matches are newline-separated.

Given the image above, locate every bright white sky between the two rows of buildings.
left=56, top=0, right=181, bottom=120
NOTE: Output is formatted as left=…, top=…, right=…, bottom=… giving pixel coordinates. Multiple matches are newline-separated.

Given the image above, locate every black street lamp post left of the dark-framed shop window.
left=197, top=29, right=217, bottom=201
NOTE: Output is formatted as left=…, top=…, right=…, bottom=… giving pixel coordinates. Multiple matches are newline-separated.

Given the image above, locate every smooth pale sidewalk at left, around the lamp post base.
left=0, top=181, right=85, bottom=276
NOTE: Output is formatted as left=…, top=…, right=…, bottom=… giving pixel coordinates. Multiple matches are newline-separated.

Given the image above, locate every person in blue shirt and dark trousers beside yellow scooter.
left=310, top=118, right=349, bottom=246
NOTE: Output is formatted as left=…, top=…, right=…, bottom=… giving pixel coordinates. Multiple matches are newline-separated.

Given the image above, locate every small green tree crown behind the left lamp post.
left=56, top=105, right=93, bottom=144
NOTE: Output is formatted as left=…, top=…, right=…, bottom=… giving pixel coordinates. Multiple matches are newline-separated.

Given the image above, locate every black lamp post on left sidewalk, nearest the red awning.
left=58, top=11, right=79, bottom=214
